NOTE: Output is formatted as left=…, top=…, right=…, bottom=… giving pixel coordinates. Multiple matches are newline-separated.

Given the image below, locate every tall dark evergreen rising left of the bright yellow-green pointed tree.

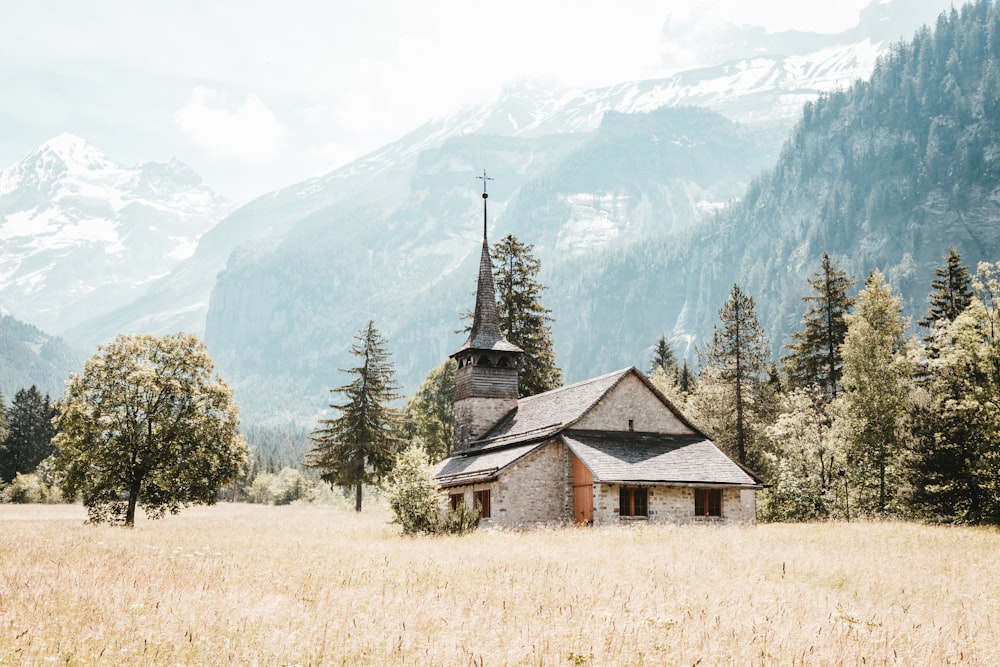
left=782, top=252, right=854, bottom=401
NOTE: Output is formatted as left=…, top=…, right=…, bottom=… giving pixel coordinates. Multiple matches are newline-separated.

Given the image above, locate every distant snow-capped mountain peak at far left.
left=0, top=134, right=233, bottom=333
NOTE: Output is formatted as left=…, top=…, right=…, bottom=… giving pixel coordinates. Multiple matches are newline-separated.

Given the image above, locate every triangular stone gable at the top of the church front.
left=573, top=373, right=695, bottom=435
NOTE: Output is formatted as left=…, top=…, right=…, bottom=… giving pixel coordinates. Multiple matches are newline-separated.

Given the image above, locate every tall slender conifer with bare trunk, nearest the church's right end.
left=699, top=284, right=768, bottom=465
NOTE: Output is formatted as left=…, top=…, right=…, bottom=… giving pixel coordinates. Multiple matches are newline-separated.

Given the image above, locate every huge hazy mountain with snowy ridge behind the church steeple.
left=47, top=0, right=960, bottom=428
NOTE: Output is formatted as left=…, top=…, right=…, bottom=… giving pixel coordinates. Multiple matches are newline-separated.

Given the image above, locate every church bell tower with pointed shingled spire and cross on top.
left=450, top=171, right=524, bottom=453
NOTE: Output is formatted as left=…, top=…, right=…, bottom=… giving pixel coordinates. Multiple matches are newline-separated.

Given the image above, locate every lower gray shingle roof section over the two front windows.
left=561, top=431, right=761, bottom=487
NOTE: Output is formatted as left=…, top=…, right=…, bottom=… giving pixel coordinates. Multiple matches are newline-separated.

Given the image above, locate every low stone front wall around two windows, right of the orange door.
left=594, top=484, right=757, bottom=526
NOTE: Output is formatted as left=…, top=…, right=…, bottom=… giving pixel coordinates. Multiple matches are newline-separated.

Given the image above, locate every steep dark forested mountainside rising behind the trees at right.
left=551, top=0, right=1000, bottom=366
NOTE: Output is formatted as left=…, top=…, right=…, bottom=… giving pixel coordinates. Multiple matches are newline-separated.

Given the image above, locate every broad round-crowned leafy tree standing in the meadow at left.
left=55, top=334, right=247, bottom=526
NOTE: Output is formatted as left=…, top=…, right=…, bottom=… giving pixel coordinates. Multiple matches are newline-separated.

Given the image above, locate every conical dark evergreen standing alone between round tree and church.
left=306, top=320, right=402, bottom=512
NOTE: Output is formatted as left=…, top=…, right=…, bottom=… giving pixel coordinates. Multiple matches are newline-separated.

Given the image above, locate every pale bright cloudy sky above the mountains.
left=0, top=0, right=916, bottom=203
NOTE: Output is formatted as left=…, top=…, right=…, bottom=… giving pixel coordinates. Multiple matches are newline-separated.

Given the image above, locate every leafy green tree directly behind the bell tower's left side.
left=404, top=359, right=455, bottom=463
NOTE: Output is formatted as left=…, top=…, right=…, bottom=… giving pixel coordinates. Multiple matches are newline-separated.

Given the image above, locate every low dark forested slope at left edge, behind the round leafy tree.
left=0, top=314, right=81, bottom=403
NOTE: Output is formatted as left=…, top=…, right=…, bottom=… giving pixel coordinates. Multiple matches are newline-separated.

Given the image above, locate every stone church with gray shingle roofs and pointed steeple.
left=435, top=175, right=763, bottom=527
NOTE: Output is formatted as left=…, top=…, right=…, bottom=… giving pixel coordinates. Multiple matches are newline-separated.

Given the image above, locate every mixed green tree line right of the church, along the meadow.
left=650, top=248, right=1000, bottom=524
